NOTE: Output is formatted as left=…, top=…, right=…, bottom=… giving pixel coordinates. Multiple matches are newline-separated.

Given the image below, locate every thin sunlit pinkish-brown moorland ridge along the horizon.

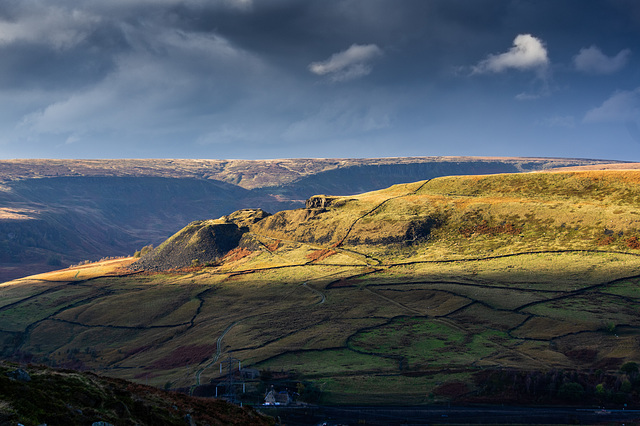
left=0, top=156, right=625, bottom=189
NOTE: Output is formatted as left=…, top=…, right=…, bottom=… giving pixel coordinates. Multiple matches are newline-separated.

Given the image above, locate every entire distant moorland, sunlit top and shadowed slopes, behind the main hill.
left=0, top=157, right=620, bottom=282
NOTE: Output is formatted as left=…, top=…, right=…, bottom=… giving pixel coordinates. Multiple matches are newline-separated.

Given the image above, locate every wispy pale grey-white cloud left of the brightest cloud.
left=309, top=44, right=382, bottom=81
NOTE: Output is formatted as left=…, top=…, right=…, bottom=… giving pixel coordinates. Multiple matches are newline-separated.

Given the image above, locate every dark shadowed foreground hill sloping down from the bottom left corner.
left=0, top=362, right=274, bottom=426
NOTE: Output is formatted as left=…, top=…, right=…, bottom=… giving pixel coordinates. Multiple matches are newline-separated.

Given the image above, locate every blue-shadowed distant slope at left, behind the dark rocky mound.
left=0, top=177, right=255, bottom=280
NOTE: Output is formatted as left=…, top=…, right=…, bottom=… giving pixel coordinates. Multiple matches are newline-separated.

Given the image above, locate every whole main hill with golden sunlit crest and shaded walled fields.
left=0, top=171, right=640, bottom=406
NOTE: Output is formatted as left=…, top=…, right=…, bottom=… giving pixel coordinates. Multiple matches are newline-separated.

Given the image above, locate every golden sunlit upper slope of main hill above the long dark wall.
left=246, top=171, right=640, bottom=258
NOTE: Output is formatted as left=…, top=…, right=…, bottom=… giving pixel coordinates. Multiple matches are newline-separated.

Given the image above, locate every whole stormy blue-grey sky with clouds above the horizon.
left=0, top=0, right=640, bottom=161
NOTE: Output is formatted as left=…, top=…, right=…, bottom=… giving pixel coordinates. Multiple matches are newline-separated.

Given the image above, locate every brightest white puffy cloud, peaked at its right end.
left=473, top=34, right=549, bottom=74
